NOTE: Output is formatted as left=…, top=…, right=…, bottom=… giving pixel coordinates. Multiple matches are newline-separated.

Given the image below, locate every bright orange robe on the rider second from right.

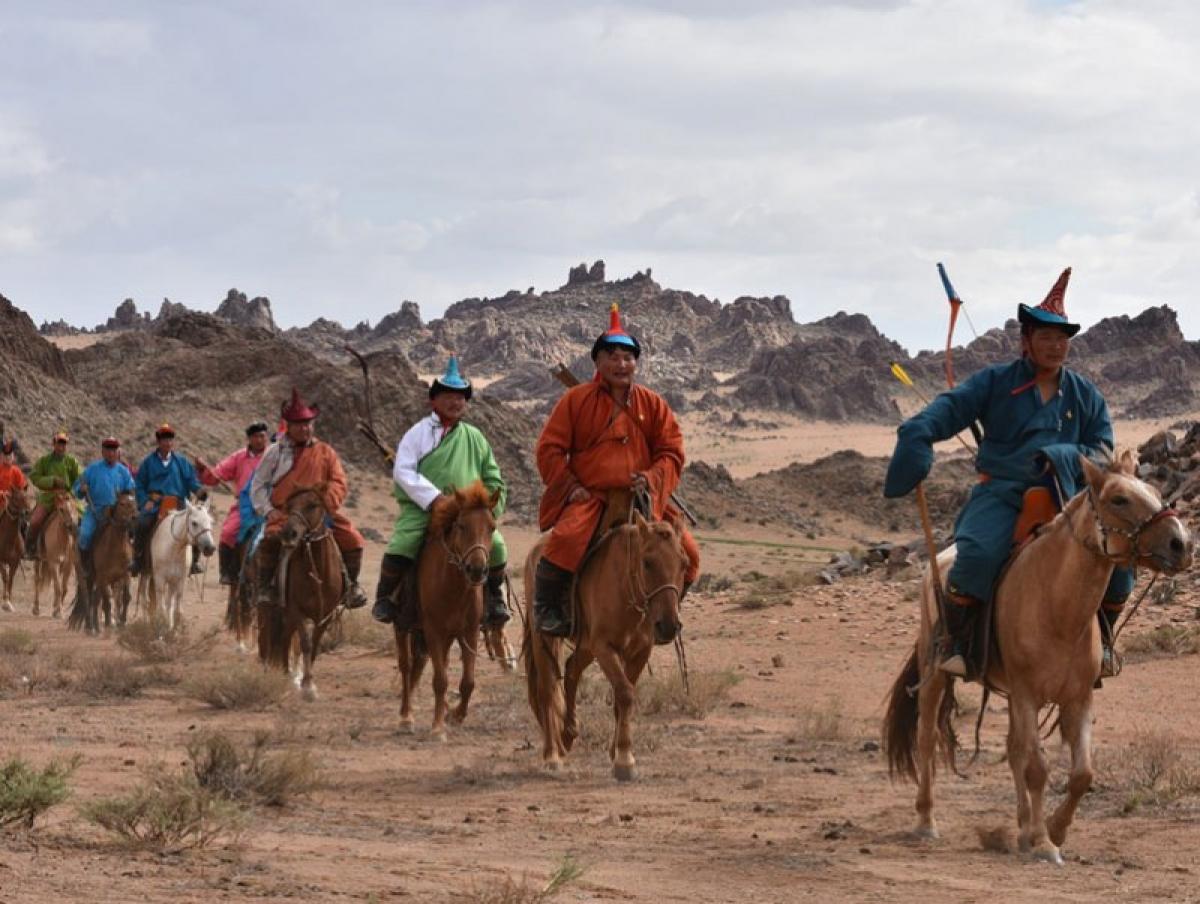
left=538, top=378, right=700, bottom=582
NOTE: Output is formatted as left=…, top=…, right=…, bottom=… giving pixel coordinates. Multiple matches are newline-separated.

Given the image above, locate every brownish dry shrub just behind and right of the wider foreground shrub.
left=187, top=731, right=319, bottom=807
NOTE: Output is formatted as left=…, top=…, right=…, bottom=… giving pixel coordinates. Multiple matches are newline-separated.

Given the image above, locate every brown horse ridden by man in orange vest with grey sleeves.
left=258, top=484, right=346, bottom=702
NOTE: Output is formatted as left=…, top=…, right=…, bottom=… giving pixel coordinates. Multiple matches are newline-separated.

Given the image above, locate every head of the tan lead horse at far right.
left=1080, top=449, right=1194, bottom=574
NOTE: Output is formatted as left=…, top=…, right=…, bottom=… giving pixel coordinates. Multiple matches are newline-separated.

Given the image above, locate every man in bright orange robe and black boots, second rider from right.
left=534, top=304, right=700, bottom=637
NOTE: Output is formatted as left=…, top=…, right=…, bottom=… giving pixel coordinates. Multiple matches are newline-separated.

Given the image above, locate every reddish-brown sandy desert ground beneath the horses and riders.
left=0, top=423, right=1200, bottom=904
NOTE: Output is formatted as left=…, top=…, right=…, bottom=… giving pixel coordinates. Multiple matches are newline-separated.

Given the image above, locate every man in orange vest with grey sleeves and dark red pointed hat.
left=250, top=389, right=367, bottom=609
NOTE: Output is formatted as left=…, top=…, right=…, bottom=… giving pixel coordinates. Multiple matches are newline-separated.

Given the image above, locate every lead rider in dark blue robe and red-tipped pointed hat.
left=883, top=268, right=1134, bottom=677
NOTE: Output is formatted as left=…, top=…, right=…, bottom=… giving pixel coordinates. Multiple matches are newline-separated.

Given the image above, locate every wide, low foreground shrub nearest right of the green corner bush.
left=79, top=772, right=246, bottom=850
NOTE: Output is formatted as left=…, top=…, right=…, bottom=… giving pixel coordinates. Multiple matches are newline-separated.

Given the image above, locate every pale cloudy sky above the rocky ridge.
left=0, top=0, right=1200, bottom=348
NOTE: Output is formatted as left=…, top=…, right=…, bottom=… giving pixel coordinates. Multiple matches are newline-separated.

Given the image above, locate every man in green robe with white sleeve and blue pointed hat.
left=371, top=357, right=510, bottom=630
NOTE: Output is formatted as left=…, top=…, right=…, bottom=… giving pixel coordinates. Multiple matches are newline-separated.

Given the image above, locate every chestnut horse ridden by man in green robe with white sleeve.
left=396, top=480, right=500, bottom=741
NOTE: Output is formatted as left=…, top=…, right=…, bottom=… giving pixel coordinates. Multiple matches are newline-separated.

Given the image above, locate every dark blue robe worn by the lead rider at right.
left=883, top=359, right=1133, bottom=601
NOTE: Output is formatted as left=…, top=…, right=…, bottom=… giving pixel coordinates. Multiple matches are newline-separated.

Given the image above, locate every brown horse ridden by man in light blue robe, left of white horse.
left=67, top=491, right=138, bottom=634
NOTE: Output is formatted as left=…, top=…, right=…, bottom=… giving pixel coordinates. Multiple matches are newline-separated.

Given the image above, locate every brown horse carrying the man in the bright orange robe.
left=522, top=495, right=688, bottom=782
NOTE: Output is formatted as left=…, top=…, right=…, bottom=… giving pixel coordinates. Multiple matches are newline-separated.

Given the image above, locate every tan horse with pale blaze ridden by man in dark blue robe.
left=883, top=451, right=1193, bottom=863
